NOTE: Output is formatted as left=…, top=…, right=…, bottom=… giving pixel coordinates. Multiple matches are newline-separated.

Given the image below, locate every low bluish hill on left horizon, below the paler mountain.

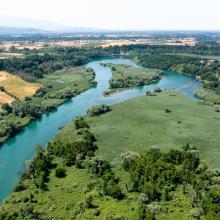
left=0, top=26, right=49, bottom=35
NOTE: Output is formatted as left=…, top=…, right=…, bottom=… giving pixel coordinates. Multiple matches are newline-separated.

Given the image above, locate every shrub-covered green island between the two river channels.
left=104, top=64, right=161, bottom=89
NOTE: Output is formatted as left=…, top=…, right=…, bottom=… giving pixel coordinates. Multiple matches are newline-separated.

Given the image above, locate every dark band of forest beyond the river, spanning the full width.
left=0, top=43, right=220, bottom=81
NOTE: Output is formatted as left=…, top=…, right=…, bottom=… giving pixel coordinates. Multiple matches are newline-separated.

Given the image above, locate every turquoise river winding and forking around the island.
left=0, top=58, right=201, bottom=202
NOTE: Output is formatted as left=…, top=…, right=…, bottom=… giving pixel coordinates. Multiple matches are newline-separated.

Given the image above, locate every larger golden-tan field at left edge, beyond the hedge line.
left=0, top=71, right=41, bottom=100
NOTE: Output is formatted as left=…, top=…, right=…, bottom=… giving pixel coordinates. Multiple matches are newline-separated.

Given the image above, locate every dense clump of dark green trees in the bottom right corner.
left=122, top=144, right=220, bottom=219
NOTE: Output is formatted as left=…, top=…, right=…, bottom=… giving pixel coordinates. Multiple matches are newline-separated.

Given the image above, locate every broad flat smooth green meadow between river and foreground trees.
left=88, top=92, right=220, bottom=167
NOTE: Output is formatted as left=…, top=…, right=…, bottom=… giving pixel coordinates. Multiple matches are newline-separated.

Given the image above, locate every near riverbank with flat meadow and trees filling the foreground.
left=0, top=91, right=220, bottom=220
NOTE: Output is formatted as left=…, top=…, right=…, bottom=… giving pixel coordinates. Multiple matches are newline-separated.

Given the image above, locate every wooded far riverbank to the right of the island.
left=133, top=53, right=220, bottom=104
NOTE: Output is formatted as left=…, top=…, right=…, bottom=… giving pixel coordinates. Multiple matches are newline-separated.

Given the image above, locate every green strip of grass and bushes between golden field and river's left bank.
left=0, top=67, right=95, bottom=143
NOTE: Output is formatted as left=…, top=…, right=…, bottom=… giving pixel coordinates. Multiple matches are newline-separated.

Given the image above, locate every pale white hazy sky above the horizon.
left=0, top=0, right=220, bottom=30
